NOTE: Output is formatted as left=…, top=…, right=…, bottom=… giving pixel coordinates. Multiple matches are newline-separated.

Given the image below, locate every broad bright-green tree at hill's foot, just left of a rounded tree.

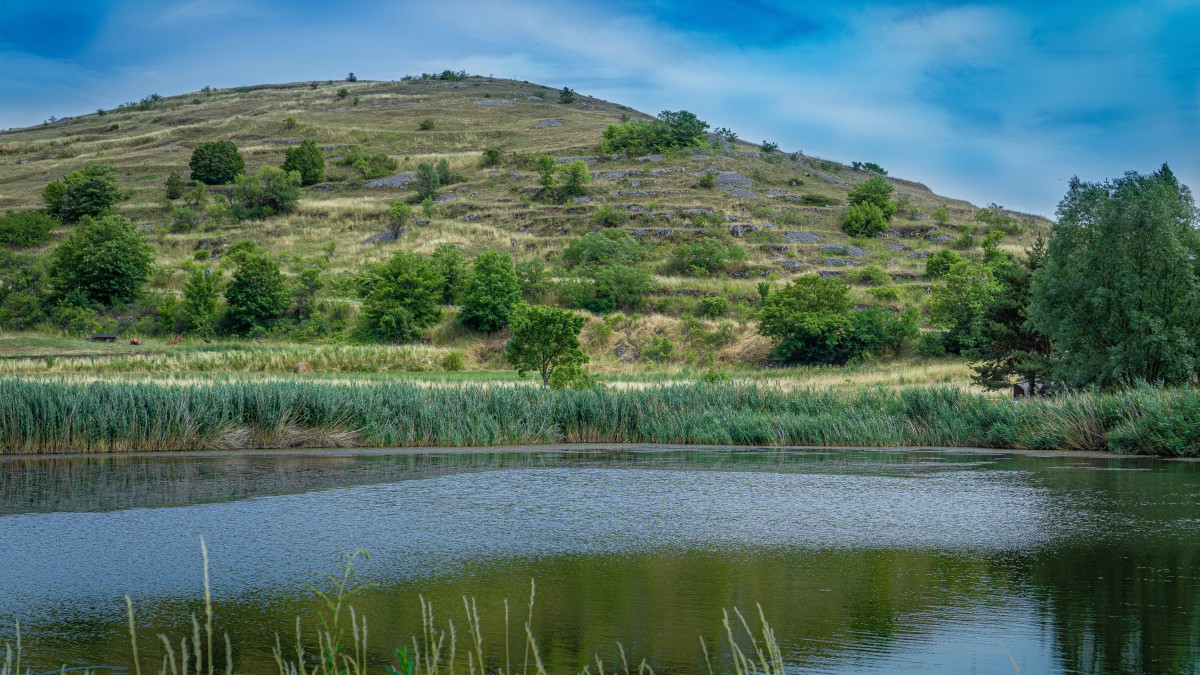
left=355, top=251, right=443, bottom=344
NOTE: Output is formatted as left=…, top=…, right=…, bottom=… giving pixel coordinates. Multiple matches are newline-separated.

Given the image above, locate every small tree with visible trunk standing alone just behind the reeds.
left=504, top=303, right=588, bottom=387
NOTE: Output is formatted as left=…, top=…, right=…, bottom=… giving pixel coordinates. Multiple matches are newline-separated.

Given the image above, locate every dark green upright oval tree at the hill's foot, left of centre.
left=224, top=252, right=292, bottom=335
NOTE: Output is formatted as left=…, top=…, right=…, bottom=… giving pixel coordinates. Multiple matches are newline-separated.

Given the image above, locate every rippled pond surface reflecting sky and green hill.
left=0, top=450, right=1200, bottom=673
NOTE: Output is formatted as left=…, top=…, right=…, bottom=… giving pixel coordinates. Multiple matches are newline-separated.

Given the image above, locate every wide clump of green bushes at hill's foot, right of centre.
left=758, top=275, right=918, bottom=364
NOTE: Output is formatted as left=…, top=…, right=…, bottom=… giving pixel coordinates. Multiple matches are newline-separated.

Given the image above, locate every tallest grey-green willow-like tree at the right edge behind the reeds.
left=1028, top=165, right=1200, bottom=387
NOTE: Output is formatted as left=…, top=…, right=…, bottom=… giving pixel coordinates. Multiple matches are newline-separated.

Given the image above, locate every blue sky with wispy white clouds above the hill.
left=0, top=0, right=1200, bottom=216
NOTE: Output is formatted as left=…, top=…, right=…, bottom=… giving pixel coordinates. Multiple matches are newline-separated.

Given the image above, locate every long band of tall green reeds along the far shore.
left=0, top=378, right=1200, bottom=456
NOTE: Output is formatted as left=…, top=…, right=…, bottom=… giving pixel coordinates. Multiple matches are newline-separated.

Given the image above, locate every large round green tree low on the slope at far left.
left=50, top=215, right=154, bottom=306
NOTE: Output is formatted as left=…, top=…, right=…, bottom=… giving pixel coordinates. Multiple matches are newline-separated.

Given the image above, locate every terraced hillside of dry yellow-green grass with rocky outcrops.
left=0, top=77, right=1049, bottom=368
